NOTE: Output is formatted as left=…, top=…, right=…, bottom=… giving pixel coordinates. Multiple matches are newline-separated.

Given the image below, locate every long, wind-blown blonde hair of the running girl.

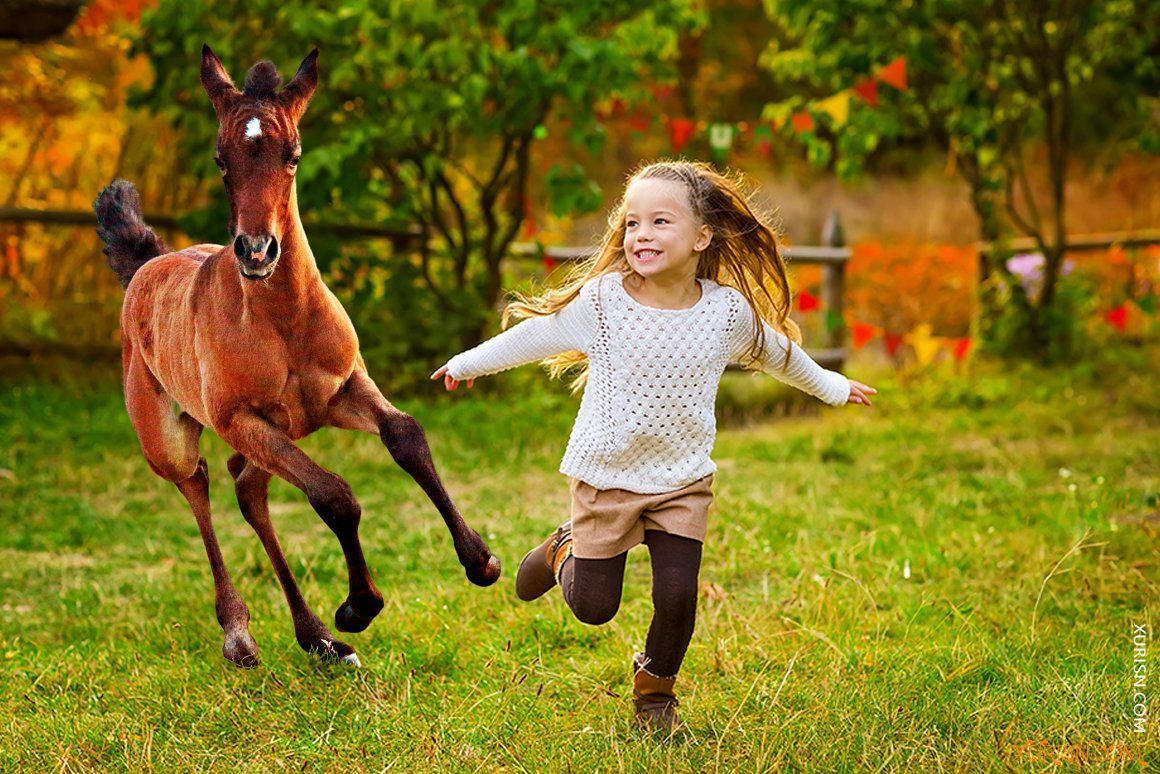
left=503, top=161, right=802, bottom=388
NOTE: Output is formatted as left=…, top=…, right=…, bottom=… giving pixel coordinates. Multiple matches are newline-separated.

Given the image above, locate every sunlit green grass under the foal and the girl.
left=0, top=356, right=1160, bottom=772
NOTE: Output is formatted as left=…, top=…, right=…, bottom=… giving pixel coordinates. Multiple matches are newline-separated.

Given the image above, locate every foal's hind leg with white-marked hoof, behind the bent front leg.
left=229, top=454, right=358, bottom=666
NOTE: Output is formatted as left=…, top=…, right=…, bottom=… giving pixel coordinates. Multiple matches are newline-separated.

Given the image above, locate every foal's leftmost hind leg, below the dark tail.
left=125, top=357, right=259, bottom=667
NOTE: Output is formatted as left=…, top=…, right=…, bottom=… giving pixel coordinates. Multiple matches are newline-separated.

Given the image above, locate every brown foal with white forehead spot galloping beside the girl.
left=93, top=45, right=500, bottom=666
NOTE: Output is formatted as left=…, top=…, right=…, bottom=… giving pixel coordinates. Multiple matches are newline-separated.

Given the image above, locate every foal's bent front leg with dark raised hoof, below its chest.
left=222, top=411, right=383, bottom=631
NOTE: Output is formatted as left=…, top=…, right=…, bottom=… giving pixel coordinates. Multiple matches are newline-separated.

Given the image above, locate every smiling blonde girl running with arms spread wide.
left=432, top=161, right=876, bottom=729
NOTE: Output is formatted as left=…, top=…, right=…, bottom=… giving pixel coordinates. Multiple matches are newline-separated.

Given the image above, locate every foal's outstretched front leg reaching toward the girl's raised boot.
left=329, top=371, right=500, bottom=586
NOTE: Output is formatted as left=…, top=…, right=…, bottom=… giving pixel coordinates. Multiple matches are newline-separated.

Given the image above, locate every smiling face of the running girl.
left=624, top=178, right=713, bottom=281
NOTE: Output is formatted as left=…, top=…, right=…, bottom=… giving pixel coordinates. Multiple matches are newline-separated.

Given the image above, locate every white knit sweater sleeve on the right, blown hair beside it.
left=730, top=294, right=850, bottom=406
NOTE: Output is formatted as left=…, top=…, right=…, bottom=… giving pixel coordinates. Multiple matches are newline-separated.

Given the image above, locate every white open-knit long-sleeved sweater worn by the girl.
left=447, top=273, right=850, bottom=494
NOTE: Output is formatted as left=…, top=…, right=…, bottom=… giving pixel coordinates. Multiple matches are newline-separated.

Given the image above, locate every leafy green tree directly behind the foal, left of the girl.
left=137, top=0, right=697, bottom=364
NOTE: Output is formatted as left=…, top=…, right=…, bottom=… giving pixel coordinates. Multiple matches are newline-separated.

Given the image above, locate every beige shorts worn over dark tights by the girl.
left=572, top=475, right=713, bottom=559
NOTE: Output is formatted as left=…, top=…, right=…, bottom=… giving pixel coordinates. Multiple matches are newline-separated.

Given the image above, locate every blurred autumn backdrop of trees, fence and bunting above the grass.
left=0, top=0, right=1160, bottom=391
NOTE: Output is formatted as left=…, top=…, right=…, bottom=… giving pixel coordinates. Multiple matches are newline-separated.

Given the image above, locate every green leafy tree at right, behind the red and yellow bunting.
left=763, top=0, right=1160, bottom=357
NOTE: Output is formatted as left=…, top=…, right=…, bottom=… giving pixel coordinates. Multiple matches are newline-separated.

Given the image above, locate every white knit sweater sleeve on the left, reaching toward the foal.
left=436, top=282, right=597, bottom=381
